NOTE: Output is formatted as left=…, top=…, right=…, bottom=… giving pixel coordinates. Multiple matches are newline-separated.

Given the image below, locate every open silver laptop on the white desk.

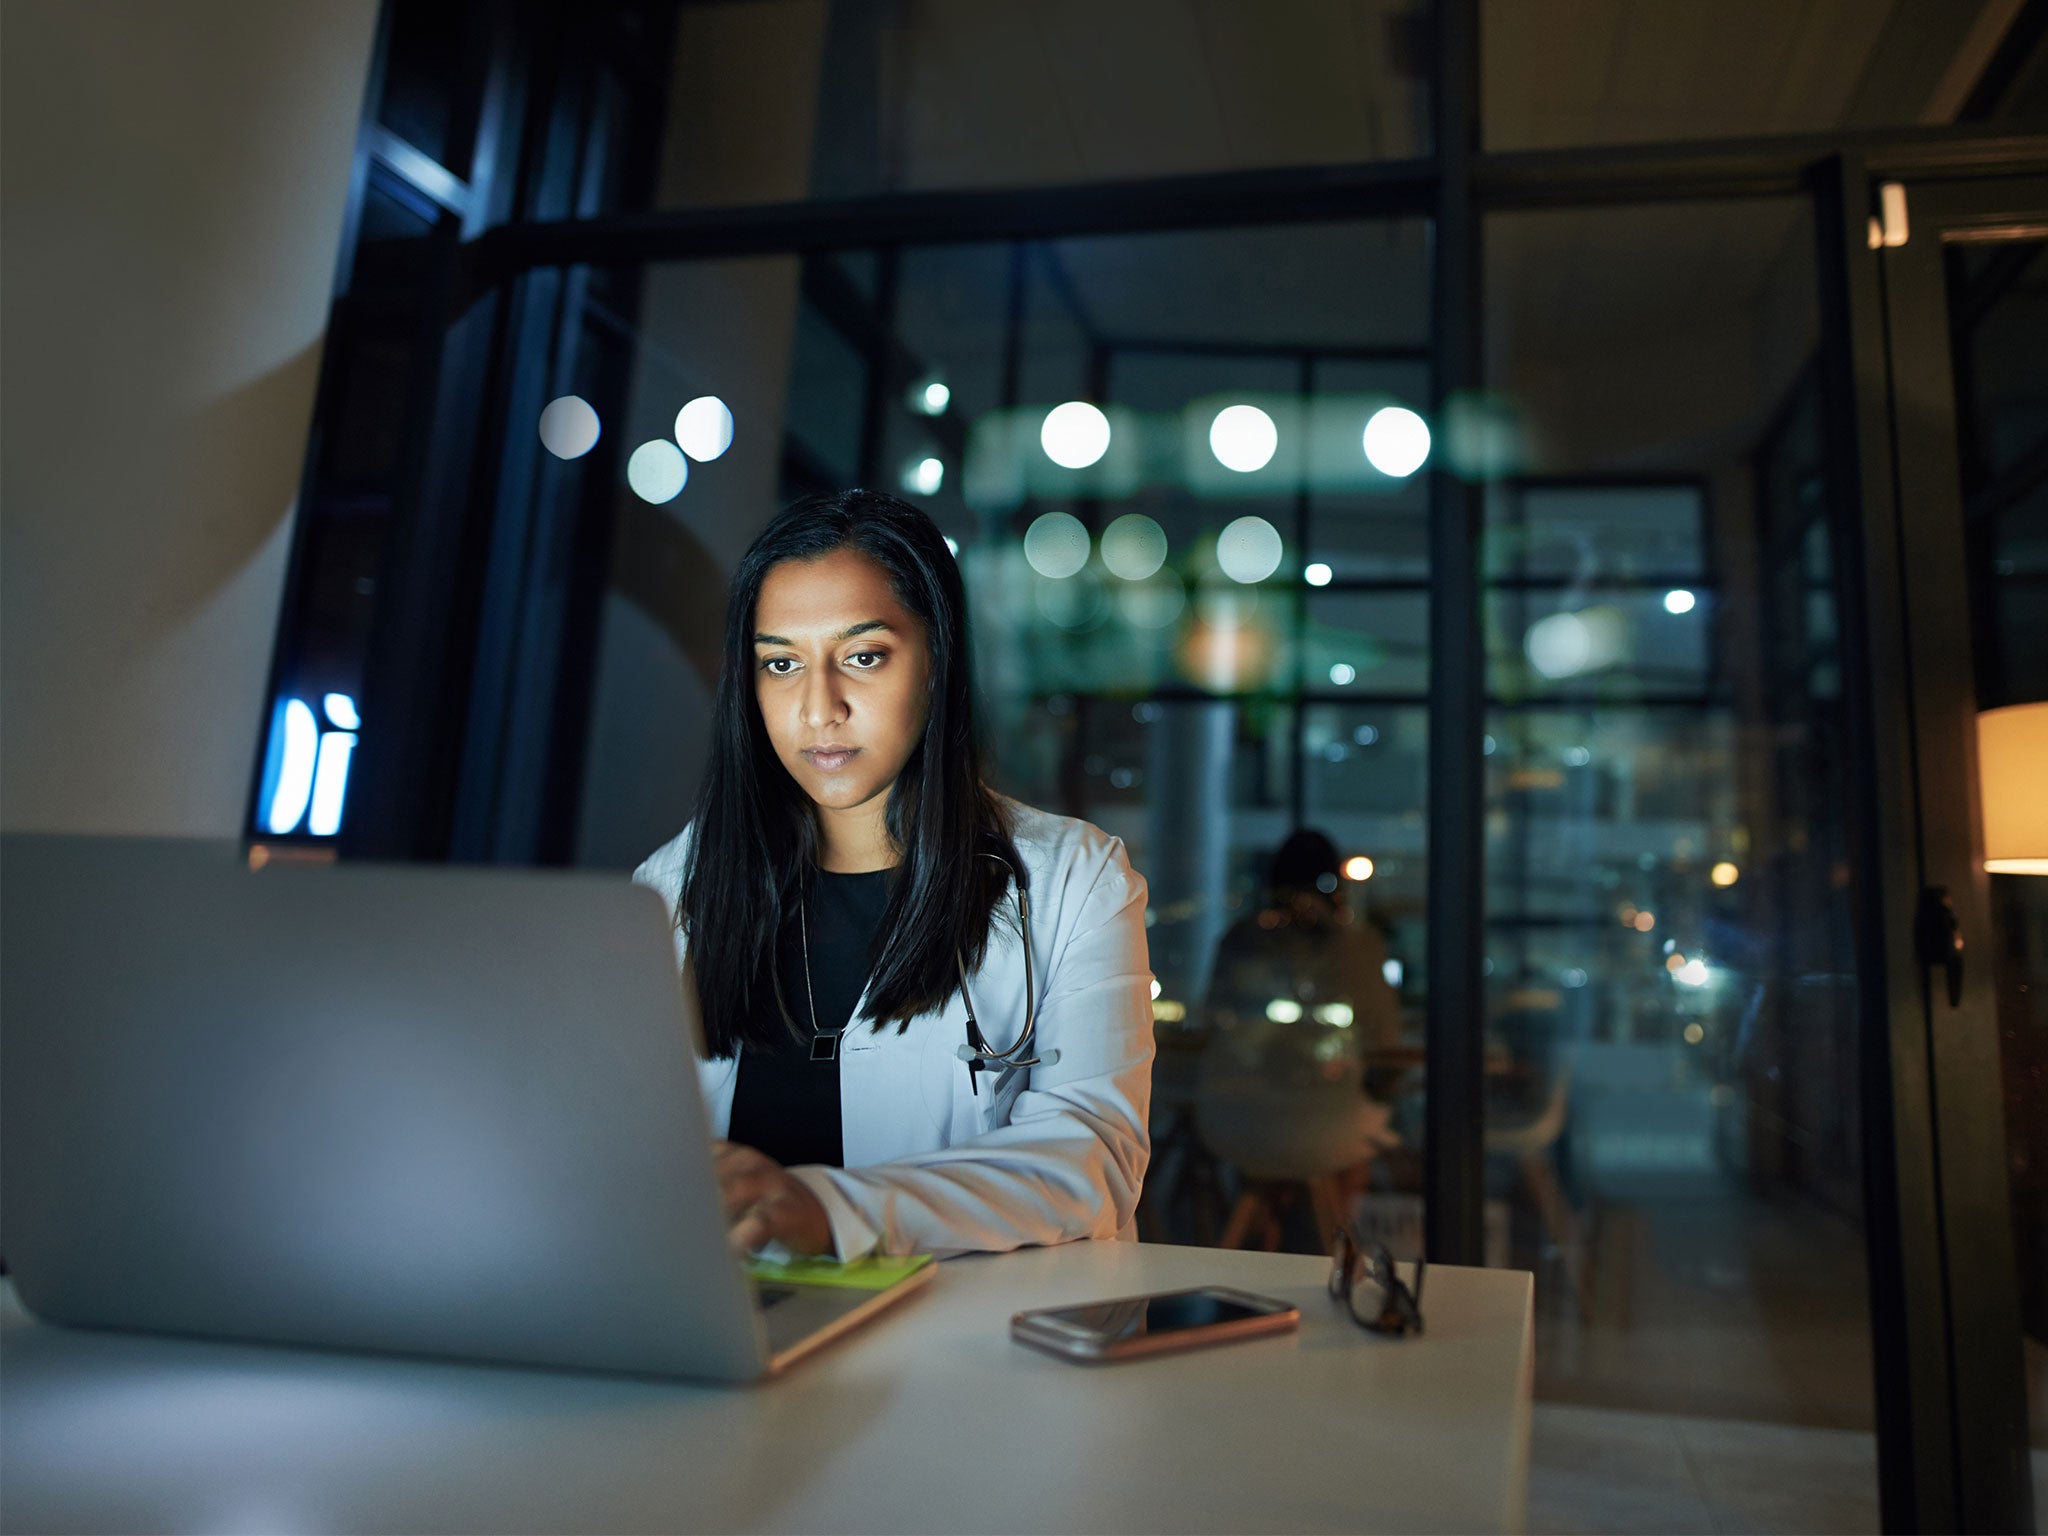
left=0, top=836, right=932, bottom=1380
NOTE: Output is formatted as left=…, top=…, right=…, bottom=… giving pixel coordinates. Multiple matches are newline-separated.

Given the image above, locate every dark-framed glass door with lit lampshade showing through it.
left=1855, top=176, right=2048, bottom=1530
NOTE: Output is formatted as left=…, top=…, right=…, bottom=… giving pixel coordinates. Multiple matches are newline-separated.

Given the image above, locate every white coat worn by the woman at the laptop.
left=633, top=801, right=1153, bottom=1257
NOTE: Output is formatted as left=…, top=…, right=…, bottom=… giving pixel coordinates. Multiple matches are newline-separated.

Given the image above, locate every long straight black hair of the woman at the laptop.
left=676, top=489, right=1026, bottom=1057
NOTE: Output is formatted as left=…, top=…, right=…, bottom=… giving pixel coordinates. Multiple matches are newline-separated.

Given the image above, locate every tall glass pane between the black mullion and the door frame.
left=1482, top=201, right=1878, bottom=1526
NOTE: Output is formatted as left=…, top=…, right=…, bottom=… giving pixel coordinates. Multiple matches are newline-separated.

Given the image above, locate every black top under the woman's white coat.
left=725, top=868, right=889, bottom=1167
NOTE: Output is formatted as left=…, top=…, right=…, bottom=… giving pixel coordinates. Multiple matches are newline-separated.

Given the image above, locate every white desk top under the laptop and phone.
left=0, top=1243, right=1532, bottom=1532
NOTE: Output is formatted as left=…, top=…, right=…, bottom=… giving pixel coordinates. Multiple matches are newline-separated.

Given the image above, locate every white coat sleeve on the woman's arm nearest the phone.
left=793, top=838, right=1153, bottom=1257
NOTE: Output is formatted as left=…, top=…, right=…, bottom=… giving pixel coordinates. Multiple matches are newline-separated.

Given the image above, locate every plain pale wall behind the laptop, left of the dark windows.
left=0, top=0, right=377, bottom=836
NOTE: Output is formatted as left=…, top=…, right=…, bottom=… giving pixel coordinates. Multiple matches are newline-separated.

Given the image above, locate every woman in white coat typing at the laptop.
left=635, top=492, right=1153, bottom=1260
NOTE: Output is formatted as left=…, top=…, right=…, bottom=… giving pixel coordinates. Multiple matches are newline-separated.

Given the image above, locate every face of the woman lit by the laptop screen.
left=754, top=549, right=932, bottom=811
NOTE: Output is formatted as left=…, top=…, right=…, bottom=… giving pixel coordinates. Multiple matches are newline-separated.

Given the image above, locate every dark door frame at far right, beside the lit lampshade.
left=1815, top=154, right=2048, bottom=1532
